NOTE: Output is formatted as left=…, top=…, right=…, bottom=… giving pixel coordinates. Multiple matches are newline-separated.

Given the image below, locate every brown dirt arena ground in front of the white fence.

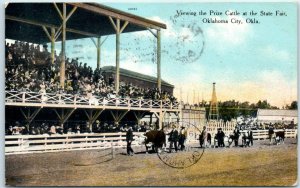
left=5, top=139, right=297, bottom=186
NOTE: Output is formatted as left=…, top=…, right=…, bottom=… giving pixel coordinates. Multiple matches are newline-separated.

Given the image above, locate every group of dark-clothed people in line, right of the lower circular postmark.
left=199, top=126, right=253, bottom=147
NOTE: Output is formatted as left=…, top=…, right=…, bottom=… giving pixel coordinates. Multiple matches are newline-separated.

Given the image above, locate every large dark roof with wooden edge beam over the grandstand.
left=5, top=3, right=166, bottom=44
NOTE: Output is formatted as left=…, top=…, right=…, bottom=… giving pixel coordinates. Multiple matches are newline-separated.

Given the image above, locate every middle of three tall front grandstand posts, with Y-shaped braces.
left=108, top=16, right=129, bottom=95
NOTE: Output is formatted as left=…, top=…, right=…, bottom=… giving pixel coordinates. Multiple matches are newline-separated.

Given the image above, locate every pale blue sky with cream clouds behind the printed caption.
left=51, top=3, right=298, bottom=108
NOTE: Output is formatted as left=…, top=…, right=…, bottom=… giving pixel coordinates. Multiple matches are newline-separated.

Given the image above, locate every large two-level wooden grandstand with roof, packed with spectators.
left=5, top=3, right=181, bottom=139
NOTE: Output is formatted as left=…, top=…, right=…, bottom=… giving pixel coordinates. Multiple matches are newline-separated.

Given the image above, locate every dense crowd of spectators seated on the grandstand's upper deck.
left=5, top=41, right=176, bottom=102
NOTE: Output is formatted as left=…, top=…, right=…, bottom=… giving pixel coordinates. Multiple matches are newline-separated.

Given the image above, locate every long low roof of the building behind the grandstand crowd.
left=101, top=66, right=174, bottom=88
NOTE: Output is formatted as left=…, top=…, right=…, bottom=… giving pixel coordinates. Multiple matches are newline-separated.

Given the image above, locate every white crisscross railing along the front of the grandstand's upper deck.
left=5, top=91, right=180, bottom=110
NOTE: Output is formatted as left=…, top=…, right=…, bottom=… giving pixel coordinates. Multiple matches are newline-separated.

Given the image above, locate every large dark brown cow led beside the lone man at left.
left=145, top=130, right=166, bottom=152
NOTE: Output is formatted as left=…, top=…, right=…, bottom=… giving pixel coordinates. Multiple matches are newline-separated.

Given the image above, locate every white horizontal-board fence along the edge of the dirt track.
left=5, top=129, right=297, bottom=155
